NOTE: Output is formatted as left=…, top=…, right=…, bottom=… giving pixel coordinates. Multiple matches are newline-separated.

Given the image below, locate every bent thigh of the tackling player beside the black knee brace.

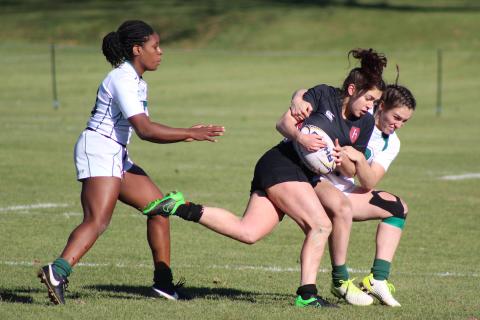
left=348, top=188, right=406, bottom=221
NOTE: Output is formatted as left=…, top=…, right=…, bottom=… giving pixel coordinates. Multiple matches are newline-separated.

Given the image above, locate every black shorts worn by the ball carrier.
left=250, top=142, right=315, bottom=193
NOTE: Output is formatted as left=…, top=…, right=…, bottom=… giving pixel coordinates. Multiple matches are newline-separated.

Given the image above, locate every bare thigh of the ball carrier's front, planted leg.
left=266, top=181, right=331, bottom=232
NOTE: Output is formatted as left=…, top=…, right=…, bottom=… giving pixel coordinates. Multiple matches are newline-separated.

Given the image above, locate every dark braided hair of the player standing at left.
left=102, top=20, right=155, bottom=67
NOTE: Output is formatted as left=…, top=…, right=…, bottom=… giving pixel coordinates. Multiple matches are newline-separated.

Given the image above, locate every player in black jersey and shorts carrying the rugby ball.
left=152, top=49, right=386, bottom=307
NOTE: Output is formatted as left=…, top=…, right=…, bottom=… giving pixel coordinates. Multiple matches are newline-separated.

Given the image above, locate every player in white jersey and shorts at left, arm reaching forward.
left=38, top=20, right=224, bottom=304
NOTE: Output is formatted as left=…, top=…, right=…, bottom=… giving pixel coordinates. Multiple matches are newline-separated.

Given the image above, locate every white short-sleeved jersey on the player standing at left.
left=87, top=62, right=148, bottom=145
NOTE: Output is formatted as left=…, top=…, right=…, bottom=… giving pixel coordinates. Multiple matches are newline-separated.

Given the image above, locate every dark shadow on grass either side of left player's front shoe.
left=85, top=285, right=291, bottom=303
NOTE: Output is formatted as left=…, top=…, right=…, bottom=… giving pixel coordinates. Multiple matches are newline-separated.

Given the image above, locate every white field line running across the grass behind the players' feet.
left=0, top=261, right=480, bottom=278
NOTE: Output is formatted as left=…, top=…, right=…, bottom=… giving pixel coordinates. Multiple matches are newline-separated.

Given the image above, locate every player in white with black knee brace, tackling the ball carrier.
left=291, top=85, right=416, bottom=306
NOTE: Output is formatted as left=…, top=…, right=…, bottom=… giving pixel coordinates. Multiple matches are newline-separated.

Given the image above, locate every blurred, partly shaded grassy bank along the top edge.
left=0, top=0, right=480, bottom=51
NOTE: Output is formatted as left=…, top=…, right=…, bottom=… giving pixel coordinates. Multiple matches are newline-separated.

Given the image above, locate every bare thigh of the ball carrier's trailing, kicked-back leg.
left=242, top=191, right=284, bottom=239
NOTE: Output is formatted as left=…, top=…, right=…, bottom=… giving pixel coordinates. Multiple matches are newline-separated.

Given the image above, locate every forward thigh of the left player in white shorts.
left=119, top=165, right=163, bottom=209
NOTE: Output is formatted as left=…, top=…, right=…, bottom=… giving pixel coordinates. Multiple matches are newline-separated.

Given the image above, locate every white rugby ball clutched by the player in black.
left=293, top=124, right=336, bottom=174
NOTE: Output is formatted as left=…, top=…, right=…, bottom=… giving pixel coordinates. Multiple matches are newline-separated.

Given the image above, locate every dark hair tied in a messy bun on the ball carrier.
left=341, top=48, right=387, bottom=97
